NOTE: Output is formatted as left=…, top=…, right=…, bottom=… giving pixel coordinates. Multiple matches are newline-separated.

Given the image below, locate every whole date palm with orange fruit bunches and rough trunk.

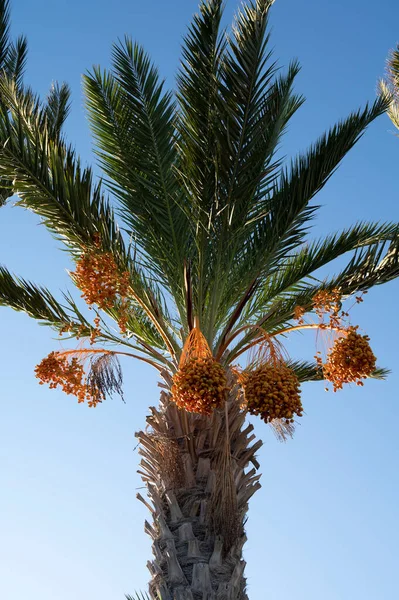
left=0, top=0, right=399, bottom=600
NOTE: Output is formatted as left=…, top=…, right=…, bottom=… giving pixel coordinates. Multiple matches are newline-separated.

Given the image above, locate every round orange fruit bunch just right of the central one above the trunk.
left=239, top=332, right=303, bottom=424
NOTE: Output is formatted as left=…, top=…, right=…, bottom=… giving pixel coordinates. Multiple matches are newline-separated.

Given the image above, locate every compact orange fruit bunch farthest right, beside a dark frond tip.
left=323, top=327, right=376, bottom=392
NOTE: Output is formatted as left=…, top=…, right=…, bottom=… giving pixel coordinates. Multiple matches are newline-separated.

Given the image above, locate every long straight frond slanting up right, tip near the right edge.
left=216, top=99, right=387, bottom=344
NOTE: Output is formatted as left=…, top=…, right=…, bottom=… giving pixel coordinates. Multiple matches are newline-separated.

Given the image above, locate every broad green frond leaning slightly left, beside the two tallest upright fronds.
left=85, top=38, right=192, bottom=314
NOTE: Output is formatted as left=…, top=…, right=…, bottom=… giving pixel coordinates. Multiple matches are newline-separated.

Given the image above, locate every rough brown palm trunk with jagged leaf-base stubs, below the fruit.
left=137, top=372, right=262, bottom=600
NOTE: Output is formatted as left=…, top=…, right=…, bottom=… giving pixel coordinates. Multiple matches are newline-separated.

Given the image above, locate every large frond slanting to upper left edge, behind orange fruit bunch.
left=0, top=81, right=180, bottom=354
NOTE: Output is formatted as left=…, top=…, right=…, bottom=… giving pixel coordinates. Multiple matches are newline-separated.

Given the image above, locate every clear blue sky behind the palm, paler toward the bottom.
left=0, top=0, right=399, bottom=600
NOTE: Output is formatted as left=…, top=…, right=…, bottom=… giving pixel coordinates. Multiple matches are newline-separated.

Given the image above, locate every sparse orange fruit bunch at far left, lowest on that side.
left=35, top=352, right=105, bottom=407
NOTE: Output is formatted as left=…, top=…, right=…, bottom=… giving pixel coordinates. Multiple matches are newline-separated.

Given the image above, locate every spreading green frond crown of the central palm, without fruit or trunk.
left=0, top=0, right=398, bottom=378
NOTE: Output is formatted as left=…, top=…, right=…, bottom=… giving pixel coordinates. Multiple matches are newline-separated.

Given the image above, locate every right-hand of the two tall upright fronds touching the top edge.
left=203, top=0, right=302, bottom=338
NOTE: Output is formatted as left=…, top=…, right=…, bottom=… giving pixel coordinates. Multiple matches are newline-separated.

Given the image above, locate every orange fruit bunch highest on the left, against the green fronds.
left=72, top=243, right=130, bottom=338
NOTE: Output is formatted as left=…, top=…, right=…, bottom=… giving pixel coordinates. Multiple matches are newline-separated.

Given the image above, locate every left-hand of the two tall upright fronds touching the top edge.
left=175, top=0, right=226, bottom=327
